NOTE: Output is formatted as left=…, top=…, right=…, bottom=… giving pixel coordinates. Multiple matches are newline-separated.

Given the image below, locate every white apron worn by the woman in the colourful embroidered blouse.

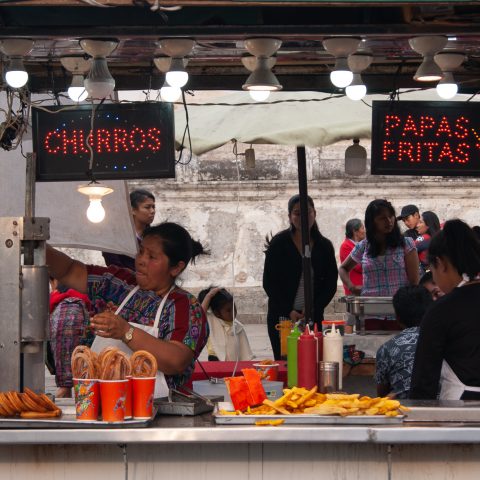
left=91, top=285, right=175, bottom=398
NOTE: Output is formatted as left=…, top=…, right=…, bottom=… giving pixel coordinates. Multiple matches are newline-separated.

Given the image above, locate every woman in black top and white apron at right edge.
left=410, top=220, right=480, bottom=400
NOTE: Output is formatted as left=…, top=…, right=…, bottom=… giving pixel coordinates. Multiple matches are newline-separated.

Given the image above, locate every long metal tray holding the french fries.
left=213, top=402, right=405, bottom=425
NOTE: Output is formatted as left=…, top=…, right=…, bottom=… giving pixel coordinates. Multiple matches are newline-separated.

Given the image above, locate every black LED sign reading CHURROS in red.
left=32, top=102, right=175, bottom=181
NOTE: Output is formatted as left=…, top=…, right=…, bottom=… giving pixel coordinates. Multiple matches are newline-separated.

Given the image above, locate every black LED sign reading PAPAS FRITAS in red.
left=372, top=101, right=480, bottom=176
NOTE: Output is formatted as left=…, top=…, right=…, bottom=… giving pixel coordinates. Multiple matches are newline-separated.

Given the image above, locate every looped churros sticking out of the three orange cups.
left=72, top=346, right=158, bottom=380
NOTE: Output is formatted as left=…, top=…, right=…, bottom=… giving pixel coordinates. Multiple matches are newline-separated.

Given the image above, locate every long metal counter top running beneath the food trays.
left=0, top=402, right=480, bottom=445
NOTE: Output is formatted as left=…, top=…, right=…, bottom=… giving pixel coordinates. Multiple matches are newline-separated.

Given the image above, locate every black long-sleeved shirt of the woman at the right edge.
left=410, top=283, right=480, bottom=399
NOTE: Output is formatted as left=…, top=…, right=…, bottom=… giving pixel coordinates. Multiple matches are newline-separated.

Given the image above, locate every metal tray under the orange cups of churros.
left=0, top=405, right=157, bottom=430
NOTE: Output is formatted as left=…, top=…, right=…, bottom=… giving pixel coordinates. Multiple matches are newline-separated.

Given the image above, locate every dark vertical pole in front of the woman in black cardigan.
left=297, top=147, right=313, bottom=328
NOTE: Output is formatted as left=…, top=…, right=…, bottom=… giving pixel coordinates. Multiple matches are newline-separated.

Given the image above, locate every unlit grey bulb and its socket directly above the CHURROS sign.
left=80, top=38, right=118, bottom=99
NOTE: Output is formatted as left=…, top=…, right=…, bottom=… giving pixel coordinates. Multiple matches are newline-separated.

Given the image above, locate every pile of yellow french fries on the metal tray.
left=220, top=386, right=408, bottom=417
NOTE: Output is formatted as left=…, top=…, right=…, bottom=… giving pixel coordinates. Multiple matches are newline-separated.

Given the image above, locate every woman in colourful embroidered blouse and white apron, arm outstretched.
left=47, top=222, right=208, bottom=396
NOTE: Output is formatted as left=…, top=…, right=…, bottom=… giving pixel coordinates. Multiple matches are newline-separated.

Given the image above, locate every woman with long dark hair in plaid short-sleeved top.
left=339, top=199, right=419, bottom=329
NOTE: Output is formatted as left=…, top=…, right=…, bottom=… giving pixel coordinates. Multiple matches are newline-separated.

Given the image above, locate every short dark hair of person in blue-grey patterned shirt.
left=392, top=285, right=433, bottom=328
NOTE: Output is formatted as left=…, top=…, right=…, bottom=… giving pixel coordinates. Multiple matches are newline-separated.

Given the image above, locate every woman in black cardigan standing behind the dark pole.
left=263, top=195, right=338, bottom=360
